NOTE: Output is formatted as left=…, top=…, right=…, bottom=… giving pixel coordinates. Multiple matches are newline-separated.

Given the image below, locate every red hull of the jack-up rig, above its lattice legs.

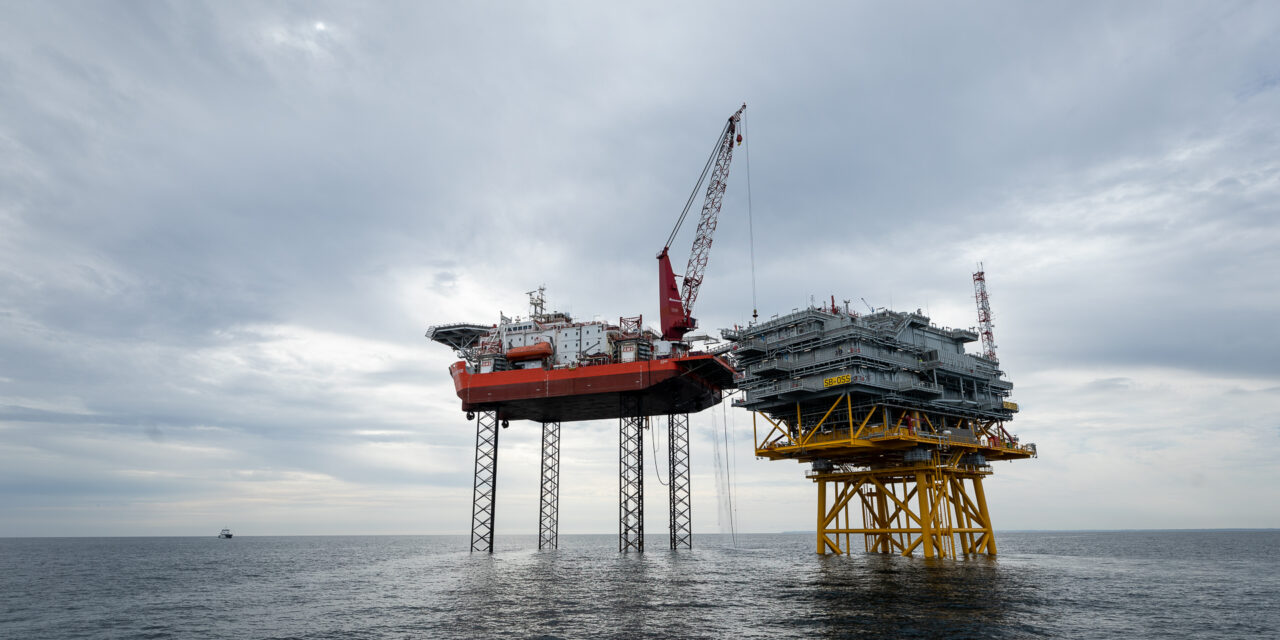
left=449, top=355, right=733, bottom=422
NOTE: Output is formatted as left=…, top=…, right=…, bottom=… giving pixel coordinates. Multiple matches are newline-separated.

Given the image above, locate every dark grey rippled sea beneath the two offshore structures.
left=0, top=530, right=1280, bottom=640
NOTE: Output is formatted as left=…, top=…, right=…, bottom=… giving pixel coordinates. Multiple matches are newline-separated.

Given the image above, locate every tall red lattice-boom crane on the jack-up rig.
left=658, top=102, right=746, bottom=340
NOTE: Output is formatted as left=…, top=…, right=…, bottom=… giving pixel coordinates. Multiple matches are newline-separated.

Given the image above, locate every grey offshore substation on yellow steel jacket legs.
left=722, top=264, right=1037, bottom=558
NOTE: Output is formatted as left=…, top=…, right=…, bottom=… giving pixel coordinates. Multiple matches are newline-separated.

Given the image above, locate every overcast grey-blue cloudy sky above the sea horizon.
left=0, top=1, right=1280, bottom=536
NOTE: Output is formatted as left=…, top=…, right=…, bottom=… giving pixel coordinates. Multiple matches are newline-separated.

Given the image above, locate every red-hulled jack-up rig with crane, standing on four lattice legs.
left=426, top=105, right=746, bottom=553
